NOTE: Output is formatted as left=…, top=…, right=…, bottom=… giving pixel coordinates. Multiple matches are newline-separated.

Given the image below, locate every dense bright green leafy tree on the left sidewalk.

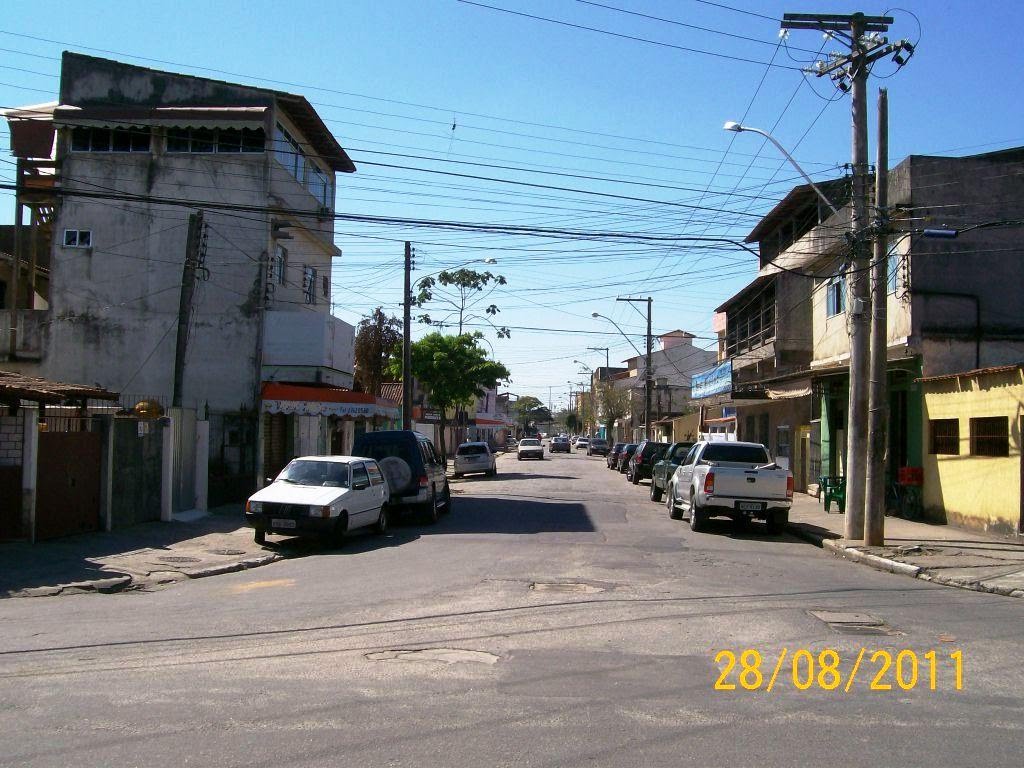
left=410, top=332, right=510, bottom=461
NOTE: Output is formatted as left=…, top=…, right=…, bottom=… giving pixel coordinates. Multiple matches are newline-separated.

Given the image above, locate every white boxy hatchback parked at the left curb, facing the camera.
left=246, top=456, right=390, bottom=544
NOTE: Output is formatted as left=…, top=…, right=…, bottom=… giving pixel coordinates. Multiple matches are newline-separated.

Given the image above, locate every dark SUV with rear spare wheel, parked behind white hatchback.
left=352, top=429, right=452, bottom=523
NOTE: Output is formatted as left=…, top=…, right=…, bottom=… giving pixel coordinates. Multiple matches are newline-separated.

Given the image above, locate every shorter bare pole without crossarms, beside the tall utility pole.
left=864, top=88, right=889, bottom=547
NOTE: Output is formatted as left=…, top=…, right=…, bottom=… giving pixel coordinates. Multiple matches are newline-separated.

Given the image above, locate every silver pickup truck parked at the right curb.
left=666, top=441, right=793, bottom=534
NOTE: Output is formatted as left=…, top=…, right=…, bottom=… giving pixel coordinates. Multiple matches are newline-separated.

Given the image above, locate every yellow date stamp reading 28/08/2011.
left=715, top=648, right=964, bottom=693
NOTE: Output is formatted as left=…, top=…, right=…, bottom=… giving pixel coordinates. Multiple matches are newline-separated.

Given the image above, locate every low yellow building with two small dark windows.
left=919, top=364, right=1024, bottom=534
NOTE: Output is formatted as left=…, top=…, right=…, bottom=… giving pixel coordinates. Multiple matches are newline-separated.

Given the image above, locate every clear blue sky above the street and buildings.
left=0, top=0, right=1024, bottom=415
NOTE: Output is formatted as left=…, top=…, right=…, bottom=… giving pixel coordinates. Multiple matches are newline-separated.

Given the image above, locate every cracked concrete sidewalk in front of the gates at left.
left=0, top=504, right=282, bottom=597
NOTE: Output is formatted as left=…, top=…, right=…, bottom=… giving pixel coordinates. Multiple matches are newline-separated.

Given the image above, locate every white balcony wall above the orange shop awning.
left=263, top=311, right=355, bottom=387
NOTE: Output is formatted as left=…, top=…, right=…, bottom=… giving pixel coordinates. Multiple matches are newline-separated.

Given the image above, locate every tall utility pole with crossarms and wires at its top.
left=782, top=13, right=913, bottom=540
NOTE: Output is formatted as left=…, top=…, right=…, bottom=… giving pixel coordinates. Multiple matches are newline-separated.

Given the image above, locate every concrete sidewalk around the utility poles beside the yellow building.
left=790, top=494, right=1024, bottom=597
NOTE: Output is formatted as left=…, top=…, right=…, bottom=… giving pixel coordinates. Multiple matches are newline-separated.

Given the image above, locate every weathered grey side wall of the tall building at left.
left=43, top=153, right=269, bottom=410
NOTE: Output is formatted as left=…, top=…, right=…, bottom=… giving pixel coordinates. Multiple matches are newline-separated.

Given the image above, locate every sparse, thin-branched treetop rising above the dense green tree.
left=414, top=268, right=511, bottom=339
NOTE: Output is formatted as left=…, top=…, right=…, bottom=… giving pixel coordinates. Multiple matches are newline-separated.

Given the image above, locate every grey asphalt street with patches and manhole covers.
left=0, top=454, right=1024, bottom=768
